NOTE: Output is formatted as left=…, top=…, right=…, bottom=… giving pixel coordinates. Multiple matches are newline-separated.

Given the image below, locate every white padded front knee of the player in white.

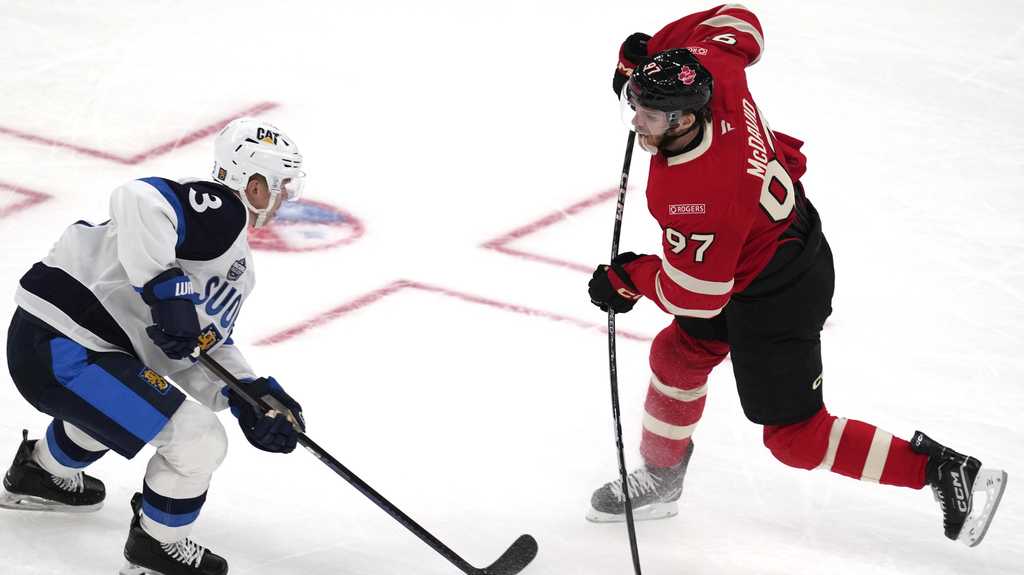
left=160, top=401, right=227, bottom=476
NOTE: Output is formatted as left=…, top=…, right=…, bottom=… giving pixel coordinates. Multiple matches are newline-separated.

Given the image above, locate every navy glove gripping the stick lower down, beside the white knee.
left=221, top=378, right=306, bottom=453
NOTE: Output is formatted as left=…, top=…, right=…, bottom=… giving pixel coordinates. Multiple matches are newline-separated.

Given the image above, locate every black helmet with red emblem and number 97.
left=627, top=48, right=712, bottom=112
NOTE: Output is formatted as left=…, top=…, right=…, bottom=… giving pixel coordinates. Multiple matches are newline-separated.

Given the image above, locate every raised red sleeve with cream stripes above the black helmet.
left=647, top=4, right=765, bottom=65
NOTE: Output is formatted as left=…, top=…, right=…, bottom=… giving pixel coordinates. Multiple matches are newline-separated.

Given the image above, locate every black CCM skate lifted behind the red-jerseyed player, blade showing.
left=910, top=432, right=1008, bottom=547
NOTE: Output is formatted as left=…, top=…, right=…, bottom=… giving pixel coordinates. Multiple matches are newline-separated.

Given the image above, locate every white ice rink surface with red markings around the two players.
left=0, top=0, right=1024, bottom=575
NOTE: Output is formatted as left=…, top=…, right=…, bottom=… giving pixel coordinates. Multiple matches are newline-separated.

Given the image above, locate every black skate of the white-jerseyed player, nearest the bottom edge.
left=121, top=487, right=227, bottom=575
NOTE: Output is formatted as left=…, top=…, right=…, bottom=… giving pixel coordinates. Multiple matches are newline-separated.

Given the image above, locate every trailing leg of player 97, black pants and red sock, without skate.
left=729, top=228, right=928, bottom=482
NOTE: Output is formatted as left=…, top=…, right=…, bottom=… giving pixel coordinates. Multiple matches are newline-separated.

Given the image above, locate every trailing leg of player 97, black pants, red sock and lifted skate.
left=730, top=229, right=1007, bottom=545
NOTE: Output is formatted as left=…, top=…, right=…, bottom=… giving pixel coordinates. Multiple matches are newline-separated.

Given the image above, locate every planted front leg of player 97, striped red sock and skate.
left=587, top=320, right=729, bottom=522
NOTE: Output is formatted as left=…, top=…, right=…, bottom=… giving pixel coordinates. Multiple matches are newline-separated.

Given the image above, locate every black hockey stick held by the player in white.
left=199, top=351, right=537, bottom=575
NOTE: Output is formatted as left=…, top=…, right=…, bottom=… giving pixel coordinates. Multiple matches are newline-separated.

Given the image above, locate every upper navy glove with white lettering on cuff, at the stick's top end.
left=142, top=267, right=200, bottom=359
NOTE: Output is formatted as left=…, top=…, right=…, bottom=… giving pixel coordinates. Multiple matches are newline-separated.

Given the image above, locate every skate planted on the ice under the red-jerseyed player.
left=587, top=441, right=693, bottom=523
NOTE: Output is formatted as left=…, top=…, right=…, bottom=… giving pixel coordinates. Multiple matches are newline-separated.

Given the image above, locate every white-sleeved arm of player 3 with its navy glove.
left=111, top=178, right=200, bottom=359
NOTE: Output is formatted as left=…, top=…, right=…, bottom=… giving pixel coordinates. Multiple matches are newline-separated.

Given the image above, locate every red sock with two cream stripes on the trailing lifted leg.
left=764, top=407, right=928, bottom=489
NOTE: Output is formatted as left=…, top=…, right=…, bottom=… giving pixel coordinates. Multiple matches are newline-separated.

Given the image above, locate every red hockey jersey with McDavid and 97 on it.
left=626, top=4, right=805, bottom=318
